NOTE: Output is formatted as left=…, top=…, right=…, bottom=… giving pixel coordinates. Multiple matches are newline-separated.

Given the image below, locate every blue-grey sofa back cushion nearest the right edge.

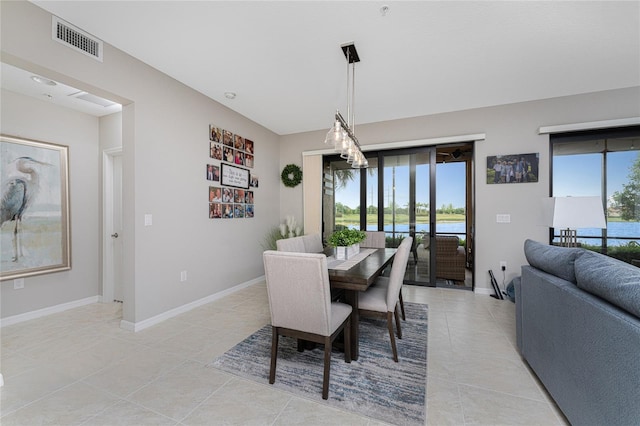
left=575, top=251, right=640, bottom=318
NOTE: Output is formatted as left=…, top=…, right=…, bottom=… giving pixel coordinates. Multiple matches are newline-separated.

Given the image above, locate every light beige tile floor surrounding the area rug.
left=0, top=283, right=567, bottom=426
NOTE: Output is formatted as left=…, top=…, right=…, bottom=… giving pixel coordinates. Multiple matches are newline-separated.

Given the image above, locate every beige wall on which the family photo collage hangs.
left=0, top=2, right=280, bottom=324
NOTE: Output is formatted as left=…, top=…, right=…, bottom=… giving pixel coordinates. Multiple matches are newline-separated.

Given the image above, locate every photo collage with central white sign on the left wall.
left=206, top=125, right=259, bottom=219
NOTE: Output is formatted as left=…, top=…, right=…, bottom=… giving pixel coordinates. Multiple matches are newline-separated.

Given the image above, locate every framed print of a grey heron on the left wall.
left=0, top=135, right=71, bottom=280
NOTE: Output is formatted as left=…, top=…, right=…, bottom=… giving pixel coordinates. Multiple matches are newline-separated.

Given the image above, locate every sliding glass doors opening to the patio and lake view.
left=323, top=142, right=473, bottom=290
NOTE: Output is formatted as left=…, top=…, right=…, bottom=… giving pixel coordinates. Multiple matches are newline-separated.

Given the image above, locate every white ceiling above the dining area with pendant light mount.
left=17, top=1, right=640, bottom=135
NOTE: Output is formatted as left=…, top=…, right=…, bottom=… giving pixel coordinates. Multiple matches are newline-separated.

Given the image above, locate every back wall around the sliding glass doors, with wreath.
left=280, top=87, right=640, bottom=293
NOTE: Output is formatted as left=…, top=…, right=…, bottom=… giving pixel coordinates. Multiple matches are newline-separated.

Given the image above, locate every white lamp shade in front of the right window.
left=542, top=197, right=607, bottom=229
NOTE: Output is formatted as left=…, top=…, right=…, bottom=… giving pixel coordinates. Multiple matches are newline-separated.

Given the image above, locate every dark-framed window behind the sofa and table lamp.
left=551, top=126, right=640, bottom=264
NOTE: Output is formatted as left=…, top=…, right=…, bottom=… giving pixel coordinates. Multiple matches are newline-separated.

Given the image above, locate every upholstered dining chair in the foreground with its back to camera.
left=263, top=250, right=352, bottom=399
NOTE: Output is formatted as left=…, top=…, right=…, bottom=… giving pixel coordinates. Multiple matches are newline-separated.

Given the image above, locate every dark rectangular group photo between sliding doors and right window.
left=487, top=153, right=540, bottom=184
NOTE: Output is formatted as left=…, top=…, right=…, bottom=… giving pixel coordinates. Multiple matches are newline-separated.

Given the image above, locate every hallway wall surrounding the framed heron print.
left=0, top=90, right=99, bottom=318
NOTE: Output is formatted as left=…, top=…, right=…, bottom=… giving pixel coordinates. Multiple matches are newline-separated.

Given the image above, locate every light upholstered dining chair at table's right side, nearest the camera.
left=358, top=237, right=413, bottom=362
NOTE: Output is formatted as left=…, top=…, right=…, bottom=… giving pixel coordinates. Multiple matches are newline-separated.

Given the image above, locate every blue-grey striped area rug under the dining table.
left=210, top=302, right=428, bottom=425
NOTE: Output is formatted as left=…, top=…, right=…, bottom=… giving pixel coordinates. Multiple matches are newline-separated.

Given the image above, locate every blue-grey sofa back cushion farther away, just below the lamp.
left=524, top=240, right=584, bottom=284
